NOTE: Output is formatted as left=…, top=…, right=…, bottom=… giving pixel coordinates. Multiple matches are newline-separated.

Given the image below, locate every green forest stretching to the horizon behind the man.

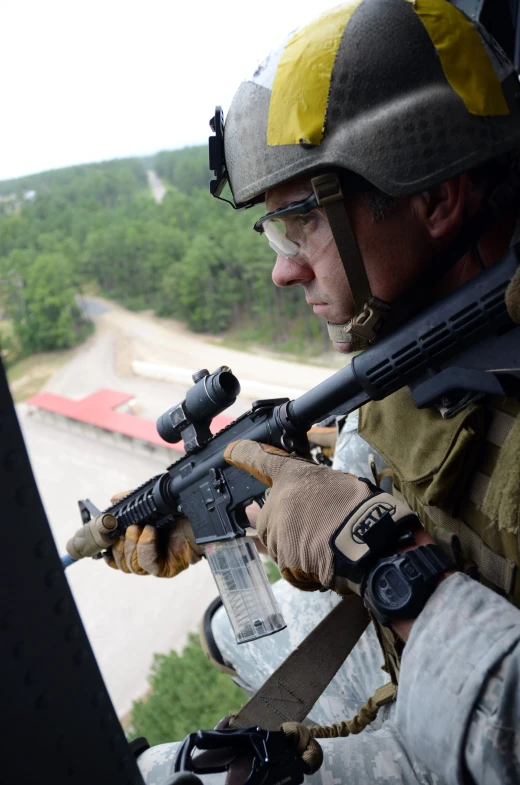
left=0, top=147, right=328, bottom=362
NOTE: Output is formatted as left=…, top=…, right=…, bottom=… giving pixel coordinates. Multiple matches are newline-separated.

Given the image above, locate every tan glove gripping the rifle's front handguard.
left=105, top=491, right=204, bottom=578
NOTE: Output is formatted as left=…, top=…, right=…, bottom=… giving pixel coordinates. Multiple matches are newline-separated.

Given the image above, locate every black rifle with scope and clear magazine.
left=64, top=245, right=520, bottom=643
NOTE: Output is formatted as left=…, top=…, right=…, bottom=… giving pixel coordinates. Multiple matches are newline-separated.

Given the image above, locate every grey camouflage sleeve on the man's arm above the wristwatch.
left=395, top=573, right=520, bottom=785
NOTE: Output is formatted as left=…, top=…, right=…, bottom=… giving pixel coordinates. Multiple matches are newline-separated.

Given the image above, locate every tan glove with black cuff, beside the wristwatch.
left=224, top=441, right=418, bottom=594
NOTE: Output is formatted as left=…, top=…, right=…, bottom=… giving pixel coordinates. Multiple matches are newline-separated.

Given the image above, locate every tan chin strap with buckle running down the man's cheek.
left=311, top=178, right=390, bottom=351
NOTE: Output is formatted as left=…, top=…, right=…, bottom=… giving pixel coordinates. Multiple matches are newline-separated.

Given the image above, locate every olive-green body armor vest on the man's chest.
left=359, top=388, right=520, bottom=681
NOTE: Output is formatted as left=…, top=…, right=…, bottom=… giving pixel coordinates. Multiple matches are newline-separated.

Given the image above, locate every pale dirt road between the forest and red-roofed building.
left=45, top=298, right=345, bottom=419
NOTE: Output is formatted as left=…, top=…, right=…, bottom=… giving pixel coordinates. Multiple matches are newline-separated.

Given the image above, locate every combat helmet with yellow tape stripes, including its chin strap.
left=210, top=0, right=520, bottom=348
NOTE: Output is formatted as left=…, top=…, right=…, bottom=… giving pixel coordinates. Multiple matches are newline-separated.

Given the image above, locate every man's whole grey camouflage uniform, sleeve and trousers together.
left=139, top=413, right=520, bottom=785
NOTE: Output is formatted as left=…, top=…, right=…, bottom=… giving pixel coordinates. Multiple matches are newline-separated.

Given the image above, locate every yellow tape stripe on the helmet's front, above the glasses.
left=267, top=0, right=363, bottom=146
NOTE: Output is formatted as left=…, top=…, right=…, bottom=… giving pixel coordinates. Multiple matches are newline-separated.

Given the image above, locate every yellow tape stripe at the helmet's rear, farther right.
left=406, top=0, right=509, bottom=116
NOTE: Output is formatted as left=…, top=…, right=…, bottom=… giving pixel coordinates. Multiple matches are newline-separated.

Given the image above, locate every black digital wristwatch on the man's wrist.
left=363, top=545, right=455, bottom=626
